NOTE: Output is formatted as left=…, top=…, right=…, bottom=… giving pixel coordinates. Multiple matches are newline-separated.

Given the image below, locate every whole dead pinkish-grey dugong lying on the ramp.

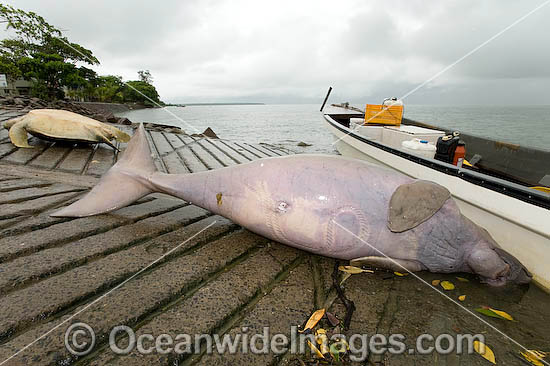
left=52, top=125, right=531, bottom=285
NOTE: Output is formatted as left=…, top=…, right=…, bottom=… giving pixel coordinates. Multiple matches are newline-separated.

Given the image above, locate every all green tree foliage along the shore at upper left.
left=0, top=4, right=162, bottom=106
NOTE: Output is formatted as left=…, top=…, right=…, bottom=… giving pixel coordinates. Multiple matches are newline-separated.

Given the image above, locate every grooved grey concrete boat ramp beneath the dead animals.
left=0, top=111, right=550, bottom=365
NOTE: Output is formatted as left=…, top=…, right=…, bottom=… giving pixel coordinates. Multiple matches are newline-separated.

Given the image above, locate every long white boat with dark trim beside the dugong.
left=323, top=104, right=550, bottom=292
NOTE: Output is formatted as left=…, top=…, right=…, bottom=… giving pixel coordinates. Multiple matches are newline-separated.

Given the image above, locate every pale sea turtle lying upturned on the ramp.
left=4, top=109, right=130, bottom=149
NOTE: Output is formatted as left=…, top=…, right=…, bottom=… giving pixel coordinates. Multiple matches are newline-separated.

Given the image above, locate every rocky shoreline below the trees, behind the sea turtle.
left=0, top=95, right=137, bottom=125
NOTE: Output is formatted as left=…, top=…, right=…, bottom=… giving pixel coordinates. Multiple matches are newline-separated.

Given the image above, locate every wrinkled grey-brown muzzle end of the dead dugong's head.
left=467, top=239, right=532, bottom=286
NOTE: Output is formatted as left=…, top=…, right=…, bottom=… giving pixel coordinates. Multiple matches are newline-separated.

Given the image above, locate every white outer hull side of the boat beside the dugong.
left=325, top=115, right=550, bottom=292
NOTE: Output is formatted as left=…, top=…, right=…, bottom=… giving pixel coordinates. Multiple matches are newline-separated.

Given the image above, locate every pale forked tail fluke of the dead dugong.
left=51, top=124, right=157, bottom=217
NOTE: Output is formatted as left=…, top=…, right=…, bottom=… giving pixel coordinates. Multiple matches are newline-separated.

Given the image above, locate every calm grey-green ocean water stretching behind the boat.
left=119, top=104, right=550, bottom=153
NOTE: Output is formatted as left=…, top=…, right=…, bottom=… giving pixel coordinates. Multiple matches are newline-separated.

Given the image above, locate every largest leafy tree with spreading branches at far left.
left=0, top=4, right=99, bottom=99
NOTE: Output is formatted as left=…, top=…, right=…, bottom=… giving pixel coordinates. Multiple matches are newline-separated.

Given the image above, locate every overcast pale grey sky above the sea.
left=3, top=0, right=550, bottom=104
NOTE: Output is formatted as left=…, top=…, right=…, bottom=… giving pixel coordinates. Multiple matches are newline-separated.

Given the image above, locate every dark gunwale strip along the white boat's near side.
left=323, top=113, right=550, bottom=210
